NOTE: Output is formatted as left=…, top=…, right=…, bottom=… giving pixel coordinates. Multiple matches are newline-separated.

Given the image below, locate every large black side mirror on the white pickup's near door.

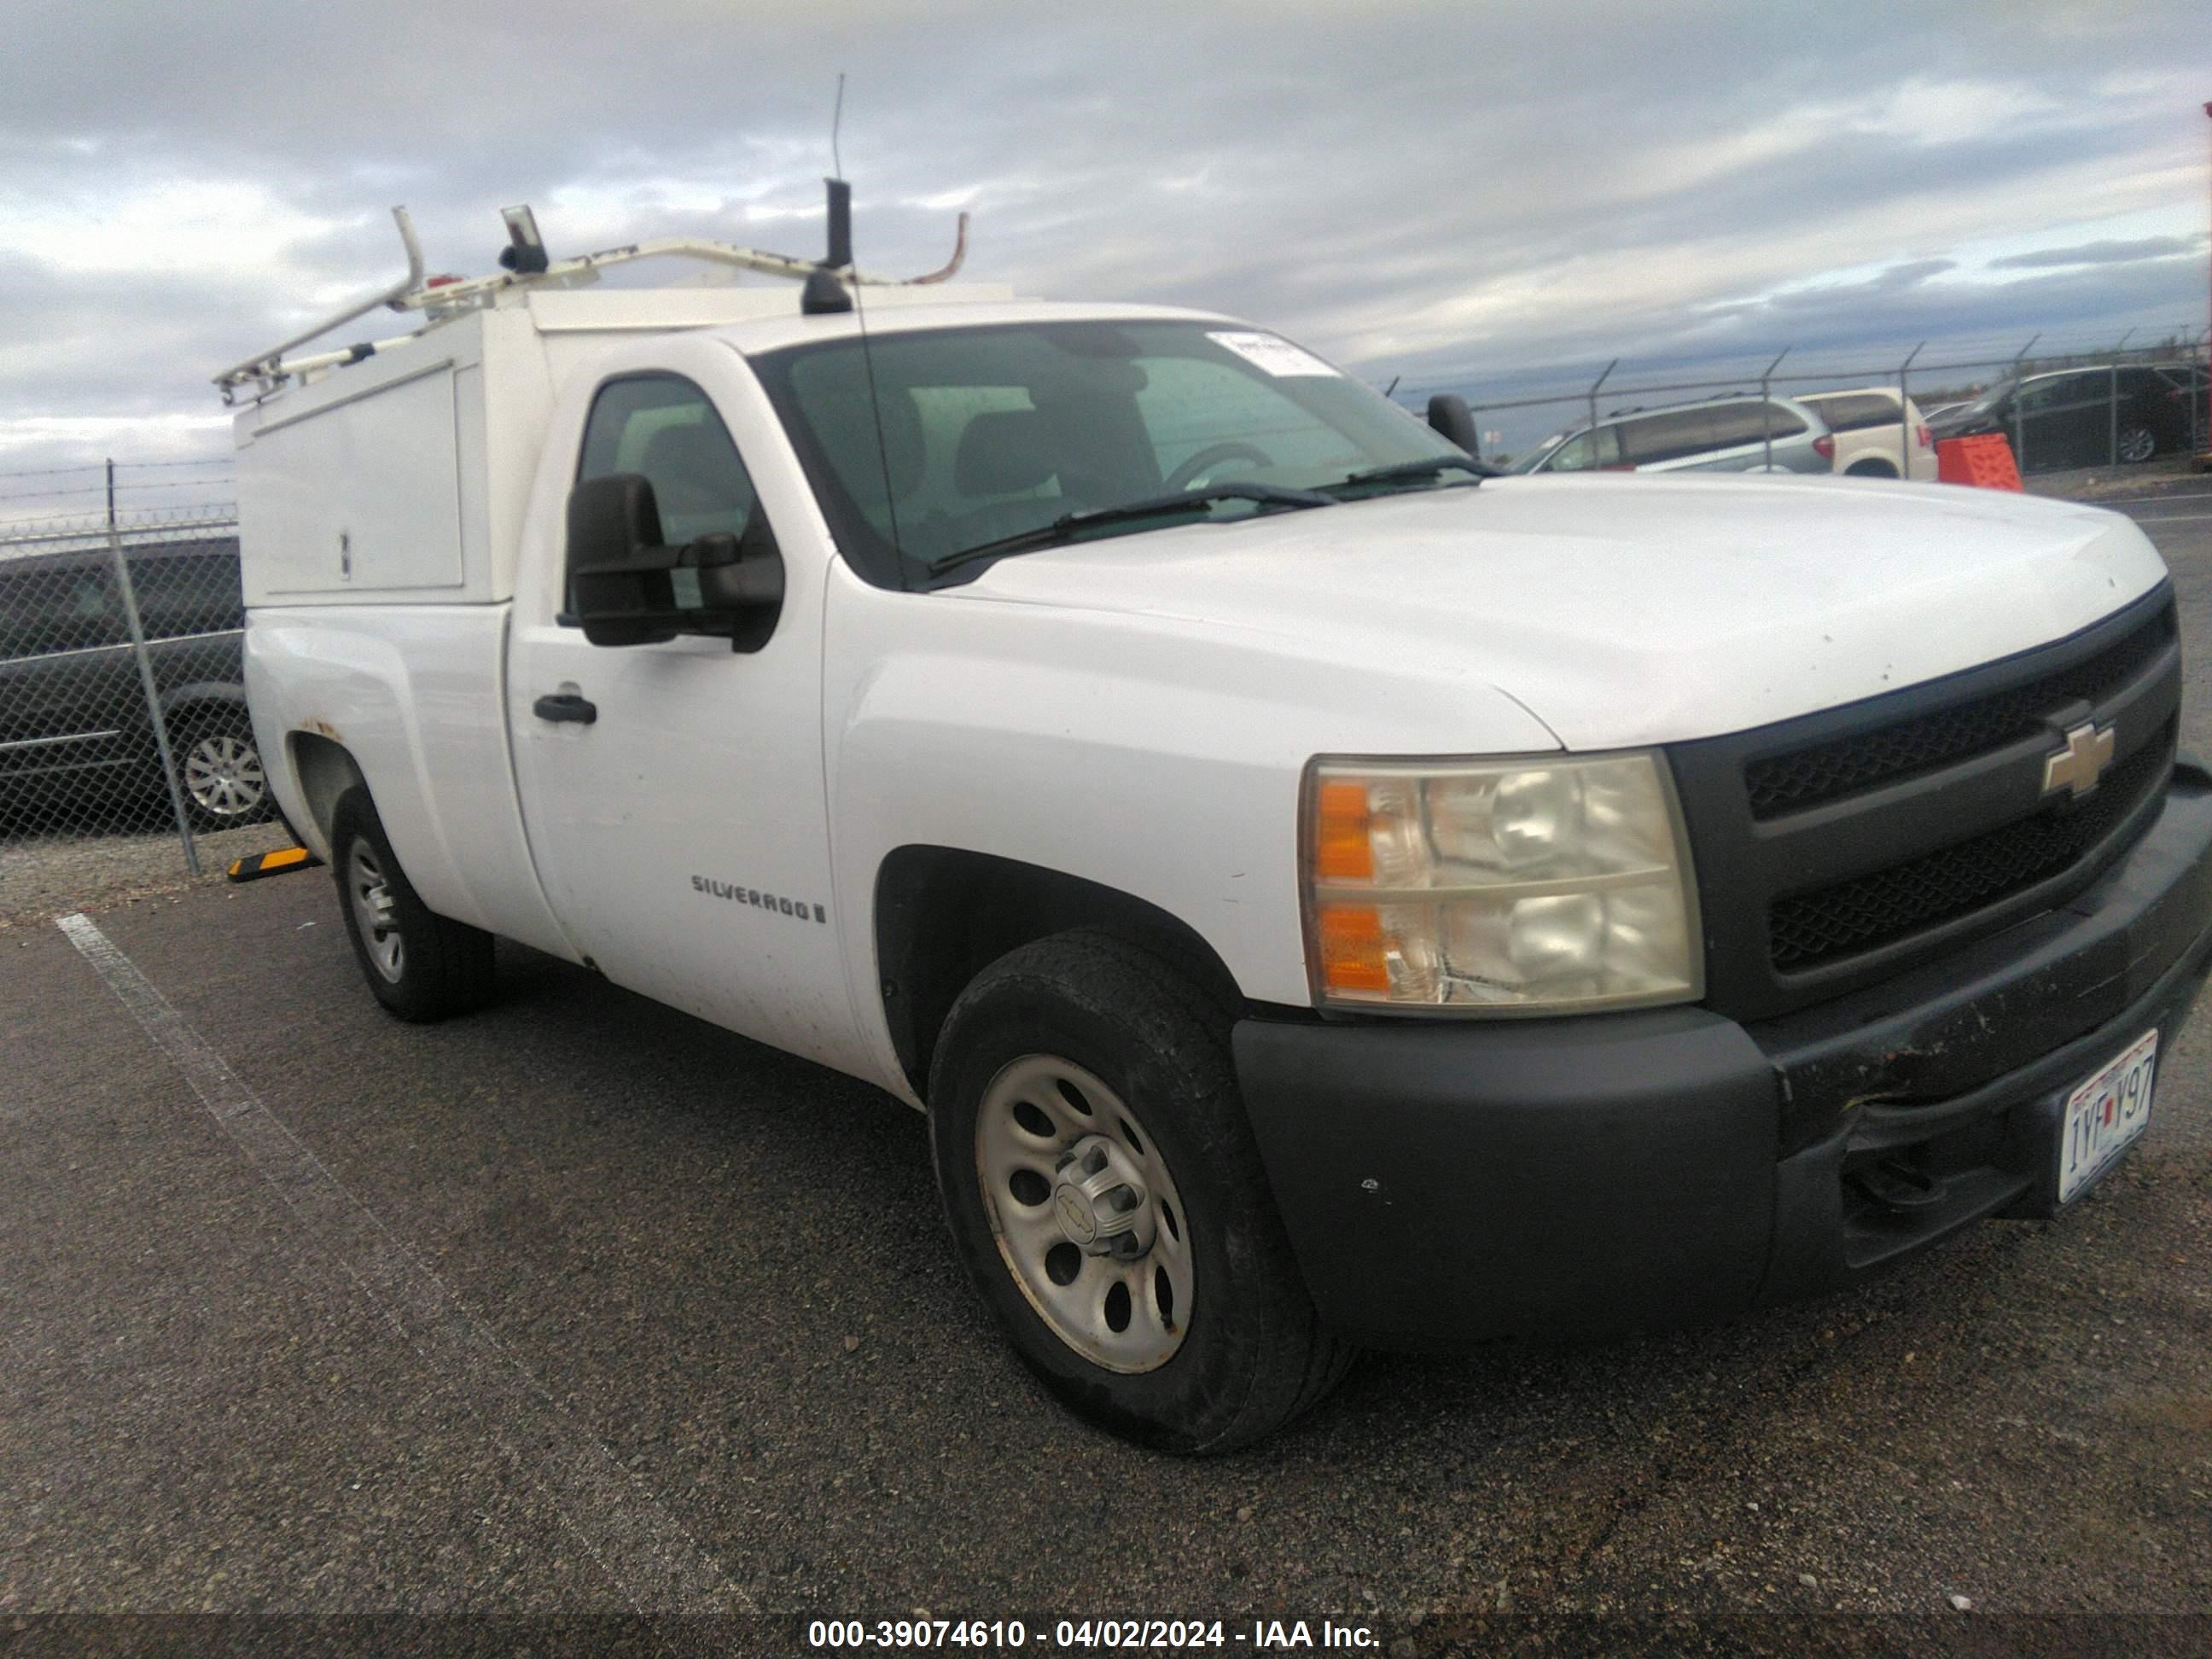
left=560, top=474, right=783, bottom=650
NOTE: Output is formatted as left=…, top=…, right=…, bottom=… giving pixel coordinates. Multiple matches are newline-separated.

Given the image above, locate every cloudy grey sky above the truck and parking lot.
left=0, top=0, right=2212, bottom=493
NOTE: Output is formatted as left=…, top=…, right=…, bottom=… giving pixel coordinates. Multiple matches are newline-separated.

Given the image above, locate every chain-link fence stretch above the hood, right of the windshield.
left=1394, top=329, right=2212, bottom=478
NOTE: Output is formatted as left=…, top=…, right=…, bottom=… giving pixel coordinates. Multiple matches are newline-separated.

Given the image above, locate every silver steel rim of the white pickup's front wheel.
left=975, top=1055, right=1195, bottom=1374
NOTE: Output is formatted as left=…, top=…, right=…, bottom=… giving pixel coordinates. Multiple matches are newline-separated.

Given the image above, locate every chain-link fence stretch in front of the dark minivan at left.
left=0, top=463, right=276, bottom=902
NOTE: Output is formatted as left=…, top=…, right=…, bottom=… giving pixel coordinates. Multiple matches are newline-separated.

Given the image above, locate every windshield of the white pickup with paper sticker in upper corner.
left=752, top=321, right=1466, bottom=586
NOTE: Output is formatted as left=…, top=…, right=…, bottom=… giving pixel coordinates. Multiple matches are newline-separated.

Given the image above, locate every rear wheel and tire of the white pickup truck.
left=329, top=785, right=493, bottom=1022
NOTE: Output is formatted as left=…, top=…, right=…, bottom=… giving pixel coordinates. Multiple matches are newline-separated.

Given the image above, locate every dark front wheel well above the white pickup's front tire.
left=876, top=847, right=1245, bottom=1095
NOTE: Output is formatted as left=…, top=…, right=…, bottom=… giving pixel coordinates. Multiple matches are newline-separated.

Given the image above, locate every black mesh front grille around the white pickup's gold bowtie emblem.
left=1668, top=584, right=2181, bottom=1020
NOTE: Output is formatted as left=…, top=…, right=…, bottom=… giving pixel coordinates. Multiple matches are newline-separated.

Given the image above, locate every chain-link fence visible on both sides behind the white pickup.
left=0, top=332, right=2212, bottom=898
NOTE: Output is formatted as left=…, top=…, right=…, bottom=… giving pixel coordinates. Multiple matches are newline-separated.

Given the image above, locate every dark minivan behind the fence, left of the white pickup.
left=0, top=538, right=274, bottom=830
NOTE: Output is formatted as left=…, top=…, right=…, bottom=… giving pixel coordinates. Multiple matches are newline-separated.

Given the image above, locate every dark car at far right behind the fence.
left=1929, top=363, right=2205, bottom=471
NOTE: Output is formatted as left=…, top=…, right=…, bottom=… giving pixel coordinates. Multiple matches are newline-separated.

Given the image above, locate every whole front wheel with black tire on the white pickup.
left=929, top=931, right=1356, bottom=1453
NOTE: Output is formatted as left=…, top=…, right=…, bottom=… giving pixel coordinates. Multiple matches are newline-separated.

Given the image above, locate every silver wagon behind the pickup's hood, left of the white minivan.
left=1511, top=399, right=1836, bottom=474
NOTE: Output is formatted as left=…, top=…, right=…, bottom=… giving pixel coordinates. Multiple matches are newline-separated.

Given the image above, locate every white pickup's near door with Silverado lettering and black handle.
left=509, top=352, right=852, bottom=1079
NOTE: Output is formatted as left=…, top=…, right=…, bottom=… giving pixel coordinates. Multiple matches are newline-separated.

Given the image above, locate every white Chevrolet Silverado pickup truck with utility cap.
left=228, top=204, right=2212, bottom=1451
